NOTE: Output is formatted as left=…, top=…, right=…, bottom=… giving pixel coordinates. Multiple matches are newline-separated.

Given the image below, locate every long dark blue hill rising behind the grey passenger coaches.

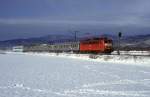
left=0, top=35, right=74, bottom=47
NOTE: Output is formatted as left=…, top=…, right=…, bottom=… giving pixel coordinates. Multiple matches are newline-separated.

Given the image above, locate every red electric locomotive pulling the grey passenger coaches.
left=80, top=37, right=113, bottom=53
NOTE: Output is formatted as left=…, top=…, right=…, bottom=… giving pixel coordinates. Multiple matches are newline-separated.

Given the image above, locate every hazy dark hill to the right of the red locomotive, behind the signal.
left=113, top=34, right=150, bottom=50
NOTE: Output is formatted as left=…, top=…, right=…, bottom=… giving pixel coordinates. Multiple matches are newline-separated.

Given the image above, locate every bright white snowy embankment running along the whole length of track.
left=9, top=51, right=150, bottom=66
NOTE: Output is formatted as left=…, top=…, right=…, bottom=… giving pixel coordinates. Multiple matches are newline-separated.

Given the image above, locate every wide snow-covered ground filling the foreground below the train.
left=0, top=53, right=150, bottom=97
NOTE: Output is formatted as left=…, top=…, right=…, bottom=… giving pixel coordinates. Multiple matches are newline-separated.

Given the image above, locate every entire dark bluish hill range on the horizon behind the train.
left=0, top=34, right=150, bottom=50
